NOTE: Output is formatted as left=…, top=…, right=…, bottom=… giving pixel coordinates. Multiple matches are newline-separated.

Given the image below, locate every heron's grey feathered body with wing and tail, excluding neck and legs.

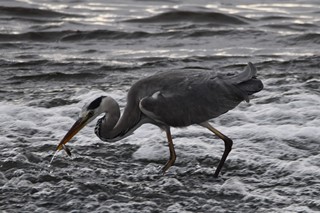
left=129, top=63, right=263, bottom=127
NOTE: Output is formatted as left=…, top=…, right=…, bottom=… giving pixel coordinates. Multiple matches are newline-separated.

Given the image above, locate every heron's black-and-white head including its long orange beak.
left=57, top=96, right=108, bottom=150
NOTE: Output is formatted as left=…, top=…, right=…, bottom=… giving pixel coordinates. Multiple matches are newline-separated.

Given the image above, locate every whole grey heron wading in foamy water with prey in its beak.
left=56, top=62, right=263, bottom=177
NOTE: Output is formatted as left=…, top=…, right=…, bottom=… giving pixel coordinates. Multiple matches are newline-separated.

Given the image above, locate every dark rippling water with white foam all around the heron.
left=0, top=0, right=320, bottom=212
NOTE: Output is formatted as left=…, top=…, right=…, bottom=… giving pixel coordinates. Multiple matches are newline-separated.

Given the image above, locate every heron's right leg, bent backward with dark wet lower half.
left=200, top=122, right=233, bottom=177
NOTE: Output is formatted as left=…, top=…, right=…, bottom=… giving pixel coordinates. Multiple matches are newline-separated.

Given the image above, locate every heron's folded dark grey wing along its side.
left=139, top=79, right=244, bottom=127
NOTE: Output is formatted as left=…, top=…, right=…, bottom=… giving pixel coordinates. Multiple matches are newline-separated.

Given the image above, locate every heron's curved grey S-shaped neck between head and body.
left=99, top=97, right=141, bottom=141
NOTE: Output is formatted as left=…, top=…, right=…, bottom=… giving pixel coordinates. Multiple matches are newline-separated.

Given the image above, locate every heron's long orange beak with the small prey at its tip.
left=56, top=115, right=91, bottom=155
